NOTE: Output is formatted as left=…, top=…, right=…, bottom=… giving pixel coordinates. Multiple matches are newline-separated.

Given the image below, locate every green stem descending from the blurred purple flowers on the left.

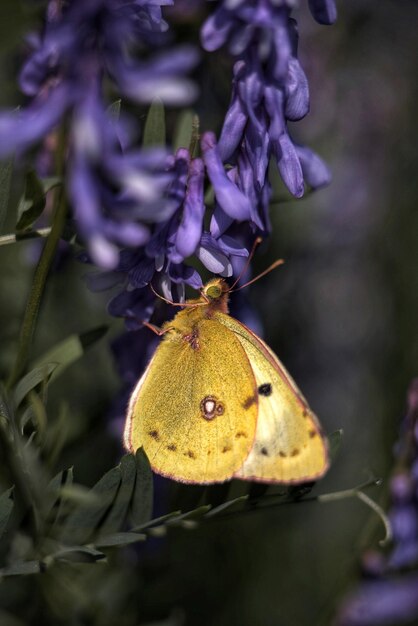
left=7, top=188, right=67, bottom=389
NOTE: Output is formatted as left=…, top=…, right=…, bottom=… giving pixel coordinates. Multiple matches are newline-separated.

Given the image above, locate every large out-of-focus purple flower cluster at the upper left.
left=0, top=0, right=196, bottom=268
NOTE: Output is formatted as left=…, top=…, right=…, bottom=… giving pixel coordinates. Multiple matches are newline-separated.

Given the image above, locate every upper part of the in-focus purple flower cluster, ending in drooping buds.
left=201, top=0, right=336, bottom=221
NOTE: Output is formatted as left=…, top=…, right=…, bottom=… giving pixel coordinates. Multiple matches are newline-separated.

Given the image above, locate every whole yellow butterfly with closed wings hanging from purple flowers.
left=124, top=278, right=328, bottom=484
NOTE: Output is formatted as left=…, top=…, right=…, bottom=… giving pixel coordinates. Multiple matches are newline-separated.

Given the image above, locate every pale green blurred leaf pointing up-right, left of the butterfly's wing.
left=34, top=326, right=108, bottom=380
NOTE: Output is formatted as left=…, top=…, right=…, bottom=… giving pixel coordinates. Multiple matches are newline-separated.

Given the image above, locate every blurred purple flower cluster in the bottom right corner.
left=336, top=379, right=418, bottom=626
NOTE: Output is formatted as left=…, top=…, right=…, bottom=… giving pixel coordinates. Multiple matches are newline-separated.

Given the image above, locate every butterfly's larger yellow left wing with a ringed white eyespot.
left=125, top=312, right=258, bottom=483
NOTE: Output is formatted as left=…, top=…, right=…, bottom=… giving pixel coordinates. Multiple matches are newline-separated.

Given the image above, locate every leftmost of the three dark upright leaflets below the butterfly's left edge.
left=61, top=460, right=122, bottom=544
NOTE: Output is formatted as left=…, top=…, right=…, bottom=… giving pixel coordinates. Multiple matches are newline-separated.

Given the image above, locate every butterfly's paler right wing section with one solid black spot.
left=216, top=313, right=328, bottom=483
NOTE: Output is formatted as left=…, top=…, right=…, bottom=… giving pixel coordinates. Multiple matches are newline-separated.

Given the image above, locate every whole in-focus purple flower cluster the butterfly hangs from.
left=90, top=0, right=335, bottom=404
